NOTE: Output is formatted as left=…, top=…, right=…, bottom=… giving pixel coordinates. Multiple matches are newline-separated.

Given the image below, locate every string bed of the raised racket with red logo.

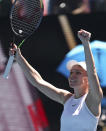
left=10, top=0, right=42, bottom=37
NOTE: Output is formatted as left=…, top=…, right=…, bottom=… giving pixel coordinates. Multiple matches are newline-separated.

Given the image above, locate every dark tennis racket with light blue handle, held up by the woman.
left=3, top=0, right=44, bottom=78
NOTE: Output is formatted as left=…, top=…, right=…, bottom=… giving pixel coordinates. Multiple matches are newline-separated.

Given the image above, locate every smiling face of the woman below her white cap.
left=68, top=65, right=88, bottom=88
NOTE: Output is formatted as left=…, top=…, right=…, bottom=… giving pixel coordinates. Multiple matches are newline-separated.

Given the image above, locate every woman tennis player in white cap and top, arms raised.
left=10, top=30, right=103, bottom=131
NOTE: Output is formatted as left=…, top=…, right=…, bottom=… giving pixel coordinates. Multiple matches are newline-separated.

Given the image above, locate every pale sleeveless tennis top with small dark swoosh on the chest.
left=60, top=94, right=99, bottom=131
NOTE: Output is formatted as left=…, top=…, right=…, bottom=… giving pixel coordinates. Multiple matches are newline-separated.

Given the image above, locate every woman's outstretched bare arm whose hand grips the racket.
left=10, top=45, right=71, bottom=104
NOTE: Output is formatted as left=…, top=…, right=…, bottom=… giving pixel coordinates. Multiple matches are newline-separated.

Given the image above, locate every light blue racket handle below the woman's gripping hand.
left=3, top=55, right=14, bottom=79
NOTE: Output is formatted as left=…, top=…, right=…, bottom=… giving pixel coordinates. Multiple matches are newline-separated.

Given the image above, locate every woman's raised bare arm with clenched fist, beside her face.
left=78, top=30, right=103, bottom=116
